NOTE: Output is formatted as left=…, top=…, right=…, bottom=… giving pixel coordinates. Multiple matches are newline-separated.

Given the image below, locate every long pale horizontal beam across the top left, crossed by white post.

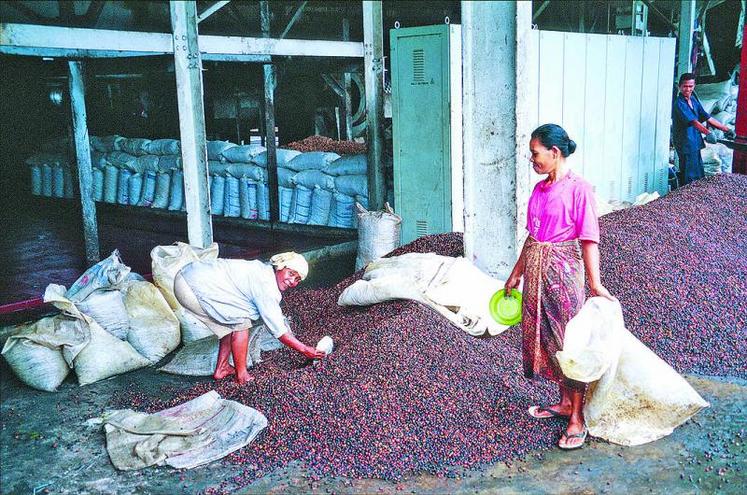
left=0, top=23, right=363, bottom=60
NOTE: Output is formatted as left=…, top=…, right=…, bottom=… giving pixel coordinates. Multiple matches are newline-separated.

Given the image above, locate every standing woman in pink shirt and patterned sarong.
left=505, top=124, right=613, bottom=449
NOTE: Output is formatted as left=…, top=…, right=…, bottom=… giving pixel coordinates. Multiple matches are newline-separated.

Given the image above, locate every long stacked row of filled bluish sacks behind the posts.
left=27, top=136, right=368, bottom=228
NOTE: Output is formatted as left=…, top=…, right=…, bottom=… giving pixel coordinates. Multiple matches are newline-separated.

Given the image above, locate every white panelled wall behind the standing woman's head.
left=517, top=31, right=675, bottom=201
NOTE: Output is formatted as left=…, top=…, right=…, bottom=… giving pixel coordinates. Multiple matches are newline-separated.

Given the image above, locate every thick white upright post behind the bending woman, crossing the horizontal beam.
left=169, top=2, right=213, bottom=248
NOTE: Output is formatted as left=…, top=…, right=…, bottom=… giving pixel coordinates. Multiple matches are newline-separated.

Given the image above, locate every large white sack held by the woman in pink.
left=557, top=297, right=709, bottom=445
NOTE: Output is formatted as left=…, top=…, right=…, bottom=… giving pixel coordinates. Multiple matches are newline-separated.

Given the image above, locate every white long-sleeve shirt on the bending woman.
left=181, top=258, right=288, bottom=338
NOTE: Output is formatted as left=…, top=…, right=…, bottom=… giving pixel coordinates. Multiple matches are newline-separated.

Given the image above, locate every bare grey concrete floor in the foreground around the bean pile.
left=0, top=362, right=747, bottom=495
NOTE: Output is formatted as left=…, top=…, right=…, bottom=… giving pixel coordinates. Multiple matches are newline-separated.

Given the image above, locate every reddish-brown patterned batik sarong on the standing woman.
left=521, top=237, right=586, bottom=390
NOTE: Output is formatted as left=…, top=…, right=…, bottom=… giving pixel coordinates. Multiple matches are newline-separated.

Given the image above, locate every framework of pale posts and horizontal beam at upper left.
left=0, top=1, right=386, bottom=254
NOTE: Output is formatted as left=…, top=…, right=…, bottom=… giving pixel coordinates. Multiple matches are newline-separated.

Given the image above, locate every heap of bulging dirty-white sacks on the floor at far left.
left=2, top=251, right=179, bottom=392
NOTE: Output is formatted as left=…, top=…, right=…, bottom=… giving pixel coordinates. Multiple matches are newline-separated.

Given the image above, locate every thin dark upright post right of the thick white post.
left=260, top=0, right=280, bottom=222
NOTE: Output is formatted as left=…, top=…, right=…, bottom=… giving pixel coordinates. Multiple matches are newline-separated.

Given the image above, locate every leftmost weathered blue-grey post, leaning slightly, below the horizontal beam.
left=68, top=60, right=101, bottom=265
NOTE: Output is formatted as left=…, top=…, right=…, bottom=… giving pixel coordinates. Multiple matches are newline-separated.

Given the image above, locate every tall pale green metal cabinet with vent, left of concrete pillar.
left=390, top=24, right=463, bottom=243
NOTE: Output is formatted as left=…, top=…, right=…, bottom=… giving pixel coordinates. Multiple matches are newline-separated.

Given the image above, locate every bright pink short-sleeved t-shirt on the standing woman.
left=527, top=171, right=599, bottom=243
